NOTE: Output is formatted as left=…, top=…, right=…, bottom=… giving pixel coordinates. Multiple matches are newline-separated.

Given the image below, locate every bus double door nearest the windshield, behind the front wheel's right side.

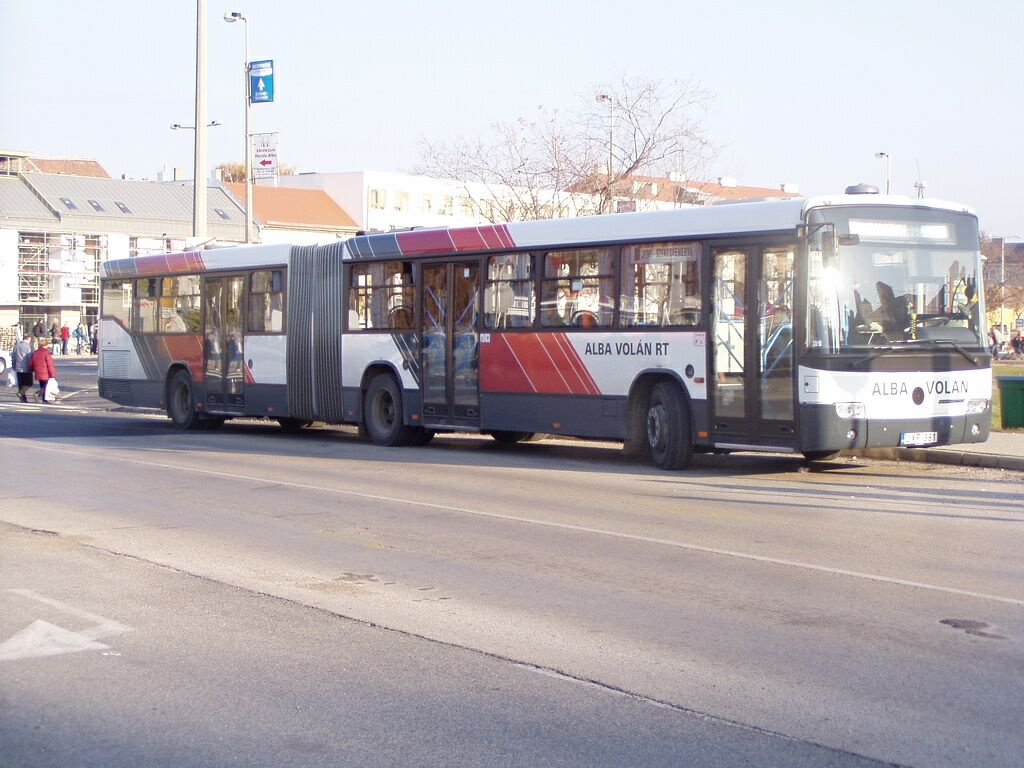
left=710, top=245, right=796, bottom=447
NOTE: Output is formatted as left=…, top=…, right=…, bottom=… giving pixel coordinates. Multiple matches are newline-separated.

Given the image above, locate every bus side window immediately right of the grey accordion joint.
left=348, top=261, right=415, bottom=331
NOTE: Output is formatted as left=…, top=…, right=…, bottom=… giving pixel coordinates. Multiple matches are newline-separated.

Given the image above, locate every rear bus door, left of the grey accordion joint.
left=203, top=274, right=246, bottom=408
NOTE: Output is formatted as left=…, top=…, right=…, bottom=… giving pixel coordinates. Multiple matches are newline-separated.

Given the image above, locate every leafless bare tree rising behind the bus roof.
left=414, top=80, right=712, bottom=222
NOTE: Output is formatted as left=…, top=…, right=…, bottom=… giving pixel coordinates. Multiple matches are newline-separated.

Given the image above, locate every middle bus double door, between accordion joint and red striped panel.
left=420, top=261, right=480, bottom=427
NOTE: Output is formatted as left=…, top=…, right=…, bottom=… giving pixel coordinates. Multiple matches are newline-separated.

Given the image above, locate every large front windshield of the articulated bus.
left=806, top=206, right=985, bottom=352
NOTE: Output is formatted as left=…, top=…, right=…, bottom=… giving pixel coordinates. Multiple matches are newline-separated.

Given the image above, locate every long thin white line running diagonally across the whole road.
left=18, top=444, right=1024, bottom=606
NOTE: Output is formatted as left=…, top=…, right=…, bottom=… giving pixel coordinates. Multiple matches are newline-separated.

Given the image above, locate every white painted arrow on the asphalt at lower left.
left=0, top=589, right=131, bottom=662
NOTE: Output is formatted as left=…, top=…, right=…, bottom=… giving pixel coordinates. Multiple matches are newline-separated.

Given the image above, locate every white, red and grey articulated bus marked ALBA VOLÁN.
left=99, top=189, right=992, bottom=469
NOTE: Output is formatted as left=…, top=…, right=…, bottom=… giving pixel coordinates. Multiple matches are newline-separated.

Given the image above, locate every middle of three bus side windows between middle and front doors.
left=541, top=248, right=615, bottom=328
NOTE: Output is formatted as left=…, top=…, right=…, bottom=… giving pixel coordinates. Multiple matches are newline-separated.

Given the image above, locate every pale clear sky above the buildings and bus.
left=0, top=0, right=1024, bottom=236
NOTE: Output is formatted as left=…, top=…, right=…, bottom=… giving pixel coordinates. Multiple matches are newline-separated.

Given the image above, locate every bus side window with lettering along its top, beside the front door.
left=618, top=243, right=700, bottom=328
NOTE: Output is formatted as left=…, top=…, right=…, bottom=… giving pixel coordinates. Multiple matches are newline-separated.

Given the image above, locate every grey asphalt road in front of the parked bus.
left=0, top=360, right=1024, bottom=766
